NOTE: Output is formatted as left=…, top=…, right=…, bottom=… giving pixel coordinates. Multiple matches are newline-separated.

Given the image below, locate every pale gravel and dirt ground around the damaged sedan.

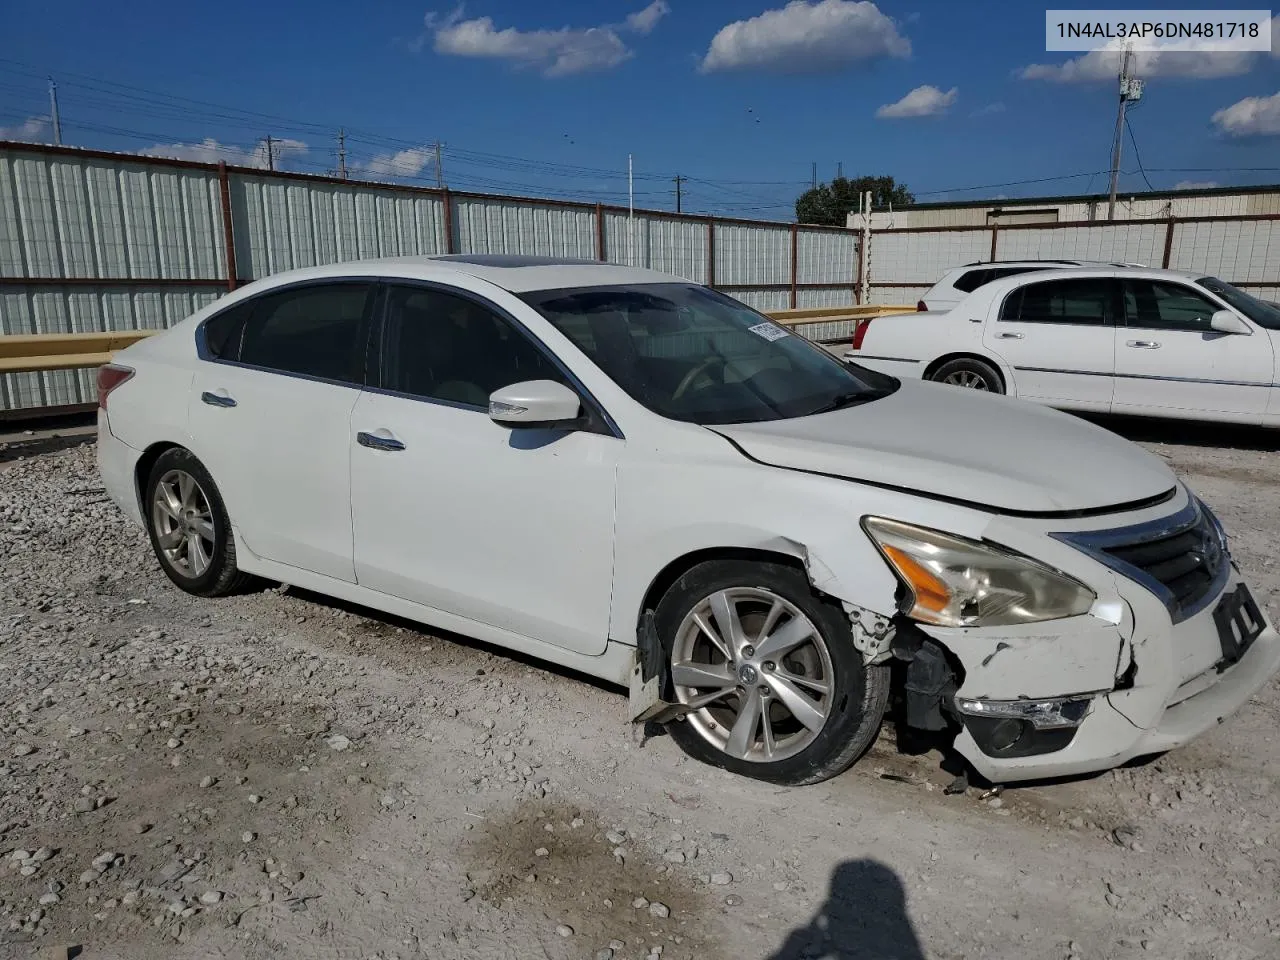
left=0, top=421, right=1280, bottom=960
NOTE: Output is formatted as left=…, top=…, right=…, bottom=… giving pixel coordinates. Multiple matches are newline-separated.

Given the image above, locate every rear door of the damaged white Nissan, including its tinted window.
left=188, top=280, right=375, bottom=582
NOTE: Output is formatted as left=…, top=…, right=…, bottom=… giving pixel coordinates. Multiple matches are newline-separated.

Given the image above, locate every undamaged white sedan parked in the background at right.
left=844, top=268, right=1280, bottom=425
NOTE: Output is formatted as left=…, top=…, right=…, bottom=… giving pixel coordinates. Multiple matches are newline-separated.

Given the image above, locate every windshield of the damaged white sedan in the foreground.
left=521, top=283, right=899, bottom=424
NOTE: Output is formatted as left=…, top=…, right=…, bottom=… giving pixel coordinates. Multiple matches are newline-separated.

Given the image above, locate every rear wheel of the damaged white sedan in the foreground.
left=143, top=448, right=250, bottom=596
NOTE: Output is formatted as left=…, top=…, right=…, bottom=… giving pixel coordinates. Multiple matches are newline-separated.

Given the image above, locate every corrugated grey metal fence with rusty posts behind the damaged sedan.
left=0, top=143, right=859, bottom=411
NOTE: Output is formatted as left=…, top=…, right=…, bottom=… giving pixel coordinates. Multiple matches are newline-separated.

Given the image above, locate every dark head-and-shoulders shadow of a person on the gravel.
left=768, top=860, right=925, bottom=960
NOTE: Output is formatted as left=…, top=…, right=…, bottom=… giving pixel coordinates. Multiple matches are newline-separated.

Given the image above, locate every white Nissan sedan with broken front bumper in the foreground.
left=99, top=256, right=1280, bottom=783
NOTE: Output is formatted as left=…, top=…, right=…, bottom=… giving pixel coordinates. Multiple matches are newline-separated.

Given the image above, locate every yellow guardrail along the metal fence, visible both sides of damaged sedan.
left=0, top=303, right=915, bottom=374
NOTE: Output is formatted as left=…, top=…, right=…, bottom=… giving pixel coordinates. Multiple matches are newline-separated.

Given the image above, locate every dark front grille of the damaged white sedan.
left=1057, top=499, right=1230, bottom=623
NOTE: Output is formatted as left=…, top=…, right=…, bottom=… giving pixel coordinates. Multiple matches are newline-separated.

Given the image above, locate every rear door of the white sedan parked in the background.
left=982, top=274, right=1119, bottom=412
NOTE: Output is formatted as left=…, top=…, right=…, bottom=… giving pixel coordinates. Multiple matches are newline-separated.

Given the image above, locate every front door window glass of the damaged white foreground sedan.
left=383, top=287, right=568, bottom=408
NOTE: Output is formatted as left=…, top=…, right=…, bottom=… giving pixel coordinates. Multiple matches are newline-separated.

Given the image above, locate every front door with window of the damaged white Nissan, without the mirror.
left=348, top=285, right=623, bottom=655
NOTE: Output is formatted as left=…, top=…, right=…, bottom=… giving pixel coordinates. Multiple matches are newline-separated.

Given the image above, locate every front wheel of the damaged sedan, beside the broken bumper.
left=654, top=561, right=888, bottom=785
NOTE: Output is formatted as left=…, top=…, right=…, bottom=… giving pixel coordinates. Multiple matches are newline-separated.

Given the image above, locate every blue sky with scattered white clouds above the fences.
left=0, top=0, right=1280, bottom=219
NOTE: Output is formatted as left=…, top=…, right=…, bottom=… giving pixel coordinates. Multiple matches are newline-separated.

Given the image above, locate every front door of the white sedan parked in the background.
left=1115, top=278, right=1275, bottom=422
